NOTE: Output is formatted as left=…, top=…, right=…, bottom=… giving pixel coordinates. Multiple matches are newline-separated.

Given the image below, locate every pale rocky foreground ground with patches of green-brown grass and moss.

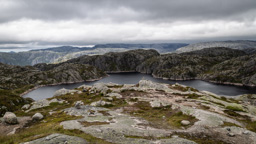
left=0, top=80, right=256, bottom=144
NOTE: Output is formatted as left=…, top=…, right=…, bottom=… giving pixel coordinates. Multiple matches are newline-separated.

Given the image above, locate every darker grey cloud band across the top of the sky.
left=0, top=0, right=256, bottom=22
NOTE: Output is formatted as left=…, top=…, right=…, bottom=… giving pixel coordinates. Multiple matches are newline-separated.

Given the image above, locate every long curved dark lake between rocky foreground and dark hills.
left=22, top=71, right=256, bottom=99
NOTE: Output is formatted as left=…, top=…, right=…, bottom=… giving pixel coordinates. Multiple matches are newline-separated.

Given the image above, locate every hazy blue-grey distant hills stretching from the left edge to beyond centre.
left=0, top=43, right=188, bottom=66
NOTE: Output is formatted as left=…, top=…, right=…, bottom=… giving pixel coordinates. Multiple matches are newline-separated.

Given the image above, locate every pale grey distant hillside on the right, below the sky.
left=176, top=40, right=256, bottom=53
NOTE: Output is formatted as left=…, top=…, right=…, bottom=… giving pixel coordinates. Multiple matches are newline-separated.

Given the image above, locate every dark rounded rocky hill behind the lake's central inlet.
left=68, top=49, right=159, bottom=72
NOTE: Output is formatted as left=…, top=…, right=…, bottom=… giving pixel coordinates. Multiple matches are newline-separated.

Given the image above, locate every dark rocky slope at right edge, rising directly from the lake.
left=203, top=54, right=256, bottom=86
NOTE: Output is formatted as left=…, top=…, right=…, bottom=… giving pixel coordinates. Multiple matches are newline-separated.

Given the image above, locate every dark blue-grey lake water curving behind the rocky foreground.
left=24, top=73, right=256, bottom=100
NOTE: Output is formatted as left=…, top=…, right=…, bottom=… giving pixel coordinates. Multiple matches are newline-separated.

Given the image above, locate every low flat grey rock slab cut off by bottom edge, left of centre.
left=22, top=134, right=88, bottom=144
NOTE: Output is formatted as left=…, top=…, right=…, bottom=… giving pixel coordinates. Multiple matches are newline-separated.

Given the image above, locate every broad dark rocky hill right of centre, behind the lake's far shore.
left=137, top=48, right=245, bottom=80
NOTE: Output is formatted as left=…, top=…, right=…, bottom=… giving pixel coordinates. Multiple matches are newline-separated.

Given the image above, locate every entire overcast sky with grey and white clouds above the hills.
left=0, top=0, right=256, bottom=47
